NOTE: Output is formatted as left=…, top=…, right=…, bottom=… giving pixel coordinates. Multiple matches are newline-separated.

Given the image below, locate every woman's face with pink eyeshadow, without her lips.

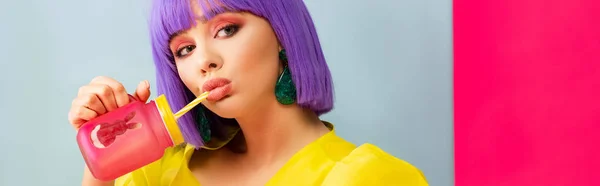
left=169, top=3, right=280, bottom=118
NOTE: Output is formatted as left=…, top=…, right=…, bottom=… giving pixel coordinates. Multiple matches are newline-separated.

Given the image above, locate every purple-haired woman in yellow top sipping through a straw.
left=69, top=0, right=427, bottom=186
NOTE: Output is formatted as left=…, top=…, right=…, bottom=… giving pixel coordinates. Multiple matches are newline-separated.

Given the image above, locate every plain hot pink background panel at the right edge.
left=453, top=0, right=600, bottom=186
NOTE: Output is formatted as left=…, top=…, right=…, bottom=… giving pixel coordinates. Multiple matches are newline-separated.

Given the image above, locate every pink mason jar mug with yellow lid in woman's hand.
left=77, top=95, right=183, bottom=181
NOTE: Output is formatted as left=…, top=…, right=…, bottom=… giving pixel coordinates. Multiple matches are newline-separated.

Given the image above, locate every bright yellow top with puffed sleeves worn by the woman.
left=115, top=122, right=428, bottom=186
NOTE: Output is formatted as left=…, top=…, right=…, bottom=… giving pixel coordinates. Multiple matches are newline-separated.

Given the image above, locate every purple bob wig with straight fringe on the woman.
left=150, top=0, right=333, bottom=147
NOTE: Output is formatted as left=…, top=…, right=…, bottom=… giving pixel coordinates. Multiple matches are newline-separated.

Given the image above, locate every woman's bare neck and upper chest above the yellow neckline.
left=236, top=103, right=329, bottom=165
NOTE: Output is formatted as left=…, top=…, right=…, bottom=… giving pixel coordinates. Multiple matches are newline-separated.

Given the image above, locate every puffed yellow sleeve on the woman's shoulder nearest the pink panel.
left=323, top=143, right=428, bottom=186
